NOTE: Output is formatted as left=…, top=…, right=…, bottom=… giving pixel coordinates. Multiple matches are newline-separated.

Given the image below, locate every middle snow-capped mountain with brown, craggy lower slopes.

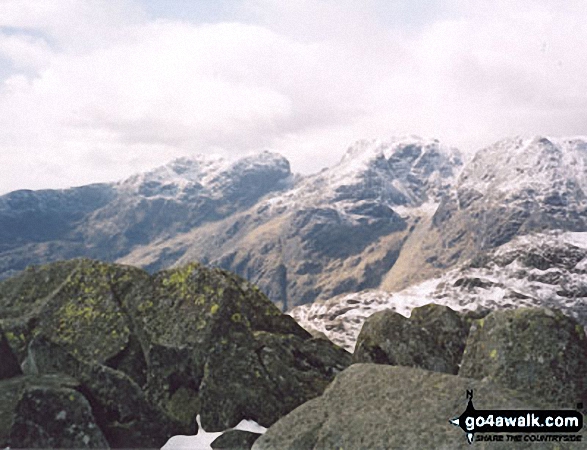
left=160, top=137, right=462, bottom=309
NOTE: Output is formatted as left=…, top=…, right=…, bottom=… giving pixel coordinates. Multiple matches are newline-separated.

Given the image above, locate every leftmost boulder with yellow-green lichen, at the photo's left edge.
left=0, top=259, right=149, bottom=372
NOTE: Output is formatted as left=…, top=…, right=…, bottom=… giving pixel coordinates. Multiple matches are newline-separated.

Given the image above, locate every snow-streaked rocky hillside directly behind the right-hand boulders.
left=289, top=231, right=587, bottom=351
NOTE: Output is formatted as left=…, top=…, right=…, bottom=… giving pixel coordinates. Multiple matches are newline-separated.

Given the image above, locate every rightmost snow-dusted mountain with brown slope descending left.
left=382, top=137, right=587, bottom=290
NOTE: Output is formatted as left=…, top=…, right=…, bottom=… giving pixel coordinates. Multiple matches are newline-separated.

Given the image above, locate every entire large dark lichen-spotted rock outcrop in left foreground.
left=0, top=260, right=351, bottom=448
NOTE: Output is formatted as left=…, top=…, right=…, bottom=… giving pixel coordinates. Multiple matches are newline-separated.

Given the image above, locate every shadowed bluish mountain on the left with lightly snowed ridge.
left=0, top=152, right=291, bottom=278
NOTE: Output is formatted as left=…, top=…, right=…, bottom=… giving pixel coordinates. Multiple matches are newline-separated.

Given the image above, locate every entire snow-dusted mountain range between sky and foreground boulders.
left=0, top=136, right=587, bottom=322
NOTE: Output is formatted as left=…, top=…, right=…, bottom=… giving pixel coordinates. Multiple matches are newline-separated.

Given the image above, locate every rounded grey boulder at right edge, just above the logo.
left=459, top=308, right=587, bottom=406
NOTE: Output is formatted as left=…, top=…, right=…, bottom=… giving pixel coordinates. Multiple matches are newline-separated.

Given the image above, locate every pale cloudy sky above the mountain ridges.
left=0, top=0, right=587, bottom=193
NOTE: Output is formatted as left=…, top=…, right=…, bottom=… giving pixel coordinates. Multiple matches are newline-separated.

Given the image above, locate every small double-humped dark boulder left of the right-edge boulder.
left=353, top=304, right=468, bottom=374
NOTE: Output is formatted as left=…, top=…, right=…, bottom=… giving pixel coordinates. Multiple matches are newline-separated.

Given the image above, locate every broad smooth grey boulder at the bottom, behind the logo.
left=253, top=364, right=586, bottom=450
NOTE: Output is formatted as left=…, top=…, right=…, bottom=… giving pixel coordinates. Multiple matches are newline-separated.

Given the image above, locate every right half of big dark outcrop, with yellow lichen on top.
left=134, top=264, right=350, bottom=431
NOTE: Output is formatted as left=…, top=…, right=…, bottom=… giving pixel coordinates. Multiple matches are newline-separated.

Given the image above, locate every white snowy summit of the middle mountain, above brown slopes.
left=255, top=136, right=462, bottom=216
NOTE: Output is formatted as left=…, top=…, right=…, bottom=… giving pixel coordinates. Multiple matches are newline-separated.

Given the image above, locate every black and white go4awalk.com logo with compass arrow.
left=450, top=390, right=583, bottom=444
